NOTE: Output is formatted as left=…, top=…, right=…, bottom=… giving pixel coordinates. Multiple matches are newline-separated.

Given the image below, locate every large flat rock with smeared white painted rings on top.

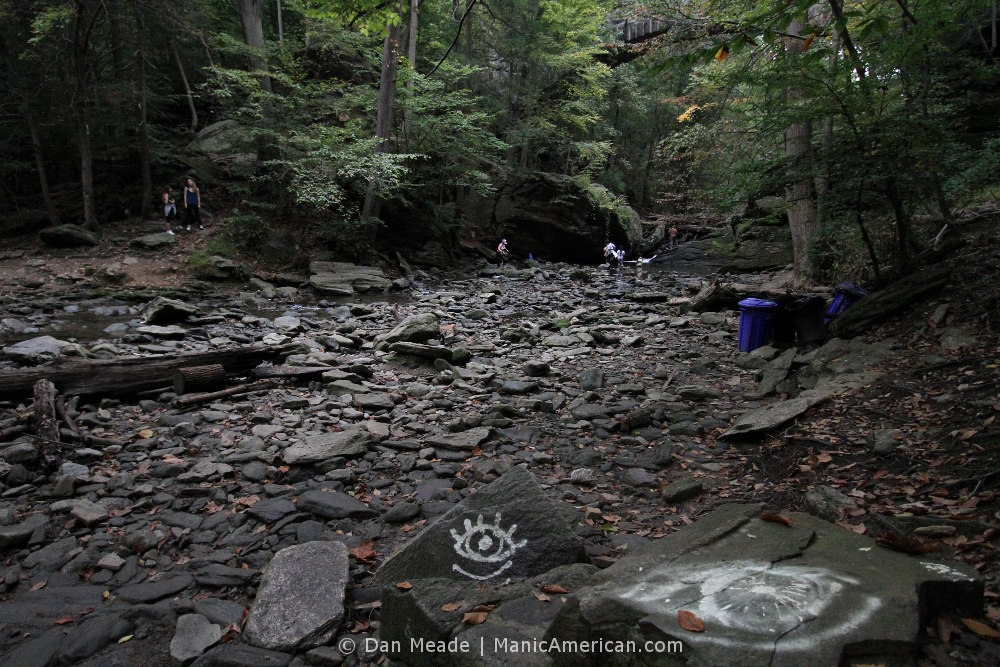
left=547, top=505, right=983, bottom=667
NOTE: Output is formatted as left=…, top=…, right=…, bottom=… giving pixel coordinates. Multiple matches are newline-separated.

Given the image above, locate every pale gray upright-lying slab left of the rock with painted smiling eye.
left=245, top=542, right=349, bottom=651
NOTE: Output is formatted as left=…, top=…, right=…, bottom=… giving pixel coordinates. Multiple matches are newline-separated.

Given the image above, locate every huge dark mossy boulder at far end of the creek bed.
left=472, top=174, right=642, bottom=264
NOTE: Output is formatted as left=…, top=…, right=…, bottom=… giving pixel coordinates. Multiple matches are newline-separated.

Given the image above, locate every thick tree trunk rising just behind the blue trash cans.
left=785, top=20, right=819, bottom=283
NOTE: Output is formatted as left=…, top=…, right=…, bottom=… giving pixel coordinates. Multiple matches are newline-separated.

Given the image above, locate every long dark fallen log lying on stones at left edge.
left=0, top=346, right=282, bottom=401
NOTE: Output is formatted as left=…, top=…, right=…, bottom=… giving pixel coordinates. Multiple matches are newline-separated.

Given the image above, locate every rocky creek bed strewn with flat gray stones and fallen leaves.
left=0, top=253, right=1000, bottom=665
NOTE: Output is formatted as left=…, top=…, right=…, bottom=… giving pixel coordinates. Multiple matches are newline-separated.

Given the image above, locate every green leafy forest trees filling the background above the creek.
left=0, top=0, right=1000, bottom=280
